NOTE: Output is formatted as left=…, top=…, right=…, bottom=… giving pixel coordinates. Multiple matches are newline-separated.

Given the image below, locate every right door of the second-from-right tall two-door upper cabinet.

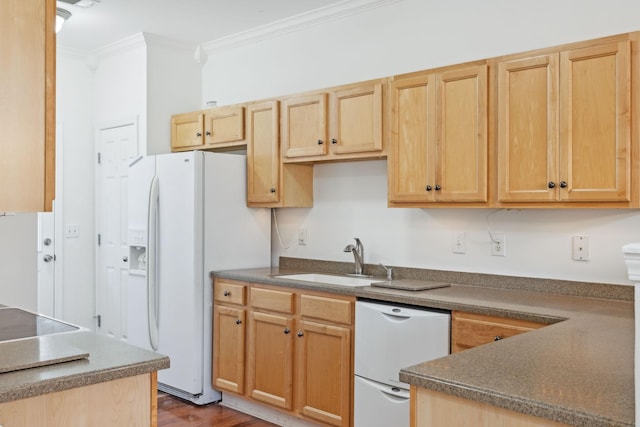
left=436, top=64, right=488, bottom=202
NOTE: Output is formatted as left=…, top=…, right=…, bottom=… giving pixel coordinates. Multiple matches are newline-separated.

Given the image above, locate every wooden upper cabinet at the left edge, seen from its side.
left=0, top=0, right=56, bottom=212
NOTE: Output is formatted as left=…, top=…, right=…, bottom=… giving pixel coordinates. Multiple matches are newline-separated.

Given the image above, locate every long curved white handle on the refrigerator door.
left=147, top=176, right=159, bottom=350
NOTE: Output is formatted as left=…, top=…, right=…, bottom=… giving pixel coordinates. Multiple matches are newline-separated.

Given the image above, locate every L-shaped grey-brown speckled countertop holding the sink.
left=212, top=260, right=635, bottom=426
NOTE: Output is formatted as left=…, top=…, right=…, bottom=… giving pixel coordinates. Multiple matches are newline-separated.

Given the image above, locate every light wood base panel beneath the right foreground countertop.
left=410, top=386, right=567, bottom=427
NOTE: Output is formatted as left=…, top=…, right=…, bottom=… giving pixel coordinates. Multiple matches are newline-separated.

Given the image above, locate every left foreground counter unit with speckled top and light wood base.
left=0, top=310, right=169, bottom=427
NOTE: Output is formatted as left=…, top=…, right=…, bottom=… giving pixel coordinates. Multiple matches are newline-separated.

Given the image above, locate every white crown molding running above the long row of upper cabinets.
left=202, top=0, right=402, bottom=53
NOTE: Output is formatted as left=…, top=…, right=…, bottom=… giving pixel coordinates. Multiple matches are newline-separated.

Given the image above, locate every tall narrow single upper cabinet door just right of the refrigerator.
left=247, top=101, right=280, bottom=203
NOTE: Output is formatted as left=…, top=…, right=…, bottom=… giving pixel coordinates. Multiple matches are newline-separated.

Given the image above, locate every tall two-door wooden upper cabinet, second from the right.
left=388, top=63, right=488, bottom=206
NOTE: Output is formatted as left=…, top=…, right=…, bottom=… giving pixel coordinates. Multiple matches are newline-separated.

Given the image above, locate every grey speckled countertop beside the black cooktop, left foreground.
left=0, top=331, right=169, bottom=403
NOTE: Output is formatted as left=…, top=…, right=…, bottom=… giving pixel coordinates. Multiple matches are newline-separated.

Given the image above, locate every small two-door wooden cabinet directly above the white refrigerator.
left=171, top=105, right=245, bottom=151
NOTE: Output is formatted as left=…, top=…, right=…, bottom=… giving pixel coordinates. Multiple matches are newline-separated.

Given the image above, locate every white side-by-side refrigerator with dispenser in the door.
left=127, top=151, right=271, bottom=405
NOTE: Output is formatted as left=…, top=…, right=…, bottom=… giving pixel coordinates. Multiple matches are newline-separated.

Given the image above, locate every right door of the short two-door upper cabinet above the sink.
left=330, top=84, right=382, bottom=154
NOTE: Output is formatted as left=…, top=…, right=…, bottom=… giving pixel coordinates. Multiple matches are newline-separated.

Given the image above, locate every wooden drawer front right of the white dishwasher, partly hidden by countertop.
left=451, top=314, right=542, bottom=353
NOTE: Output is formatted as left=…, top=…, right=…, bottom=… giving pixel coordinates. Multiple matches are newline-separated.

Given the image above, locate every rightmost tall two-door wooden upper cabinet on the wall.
left=497, top=37, right=632, bottom=207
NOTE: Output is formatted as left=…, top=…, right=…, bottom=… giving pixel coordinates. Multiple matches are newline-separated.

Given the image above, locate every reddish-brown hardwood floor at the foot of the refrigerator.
left=158, top=392, right=277, bottom=427
